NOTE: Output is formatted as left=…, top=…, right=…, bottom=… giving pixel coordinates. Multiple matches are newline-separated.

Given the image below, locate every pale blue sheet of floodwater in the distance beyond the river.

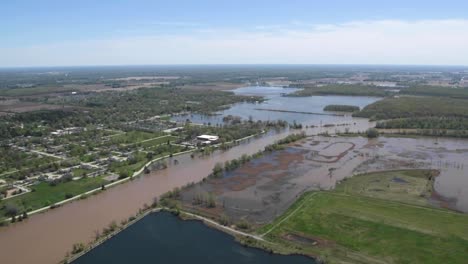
left=173, top=86, right=381, bottom=125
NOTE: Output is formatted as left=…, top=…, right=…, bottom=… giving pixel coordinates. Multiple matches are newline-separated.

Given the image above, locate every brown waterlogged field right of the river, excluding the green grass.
left=181, top=137, right=468, bottom=224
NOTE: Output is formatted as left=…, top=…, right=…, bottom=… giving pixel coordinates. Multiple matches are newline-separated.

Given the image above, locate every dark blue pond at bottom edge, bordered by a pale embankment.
left=73, top=212, right=316, bottom=264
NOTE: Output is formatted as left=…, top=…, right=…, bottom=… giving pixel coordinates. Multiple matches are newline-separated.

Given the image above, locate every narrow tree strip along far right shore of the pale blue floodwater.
left=289, top=84, right=389, bottom=97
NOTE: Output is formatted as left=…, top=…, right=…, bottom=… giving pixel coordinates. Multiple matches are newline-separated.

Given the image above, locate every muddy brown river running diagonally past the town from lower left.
left=0, top=119, right=370, bottom=264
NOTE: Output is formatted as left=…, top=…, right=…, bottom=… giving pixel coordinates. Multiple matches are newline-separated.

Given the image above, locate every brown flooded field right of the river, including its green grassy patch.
left=177, top=137, right=468, bottom=225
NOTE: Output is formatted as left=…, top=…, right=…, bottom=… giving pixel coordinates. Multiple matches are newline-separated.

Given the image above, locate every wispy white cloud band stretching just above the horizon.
left=0, top=19, right=468, bottom=66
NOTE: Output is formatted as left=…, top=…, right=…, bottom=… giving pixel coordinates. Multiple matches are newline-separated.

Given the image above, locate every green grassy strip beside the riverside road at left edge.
left=0, top=177, right=107, bottom=218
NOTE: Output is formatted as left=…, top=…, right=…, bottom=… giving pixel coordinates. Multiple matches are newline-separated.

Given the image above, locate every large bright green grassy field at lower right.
left=258, top=171, right=468, bottom=263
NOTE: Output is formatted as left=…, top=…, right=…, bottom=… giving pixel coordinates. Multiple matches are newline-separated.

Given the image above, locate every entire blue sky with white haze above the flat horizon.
left=0, top=0, right=468, bottom=67
